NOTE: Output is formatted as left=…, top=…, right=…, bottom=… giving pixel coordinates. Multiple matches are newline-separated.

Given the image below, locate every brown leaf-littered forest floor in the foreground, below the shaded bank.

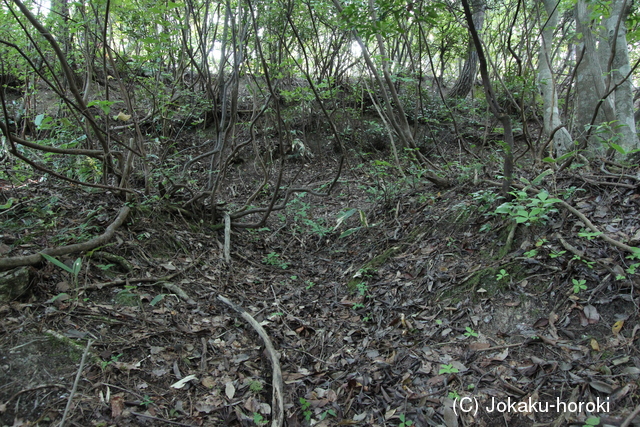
left=0, top=135, right=640, bottom=427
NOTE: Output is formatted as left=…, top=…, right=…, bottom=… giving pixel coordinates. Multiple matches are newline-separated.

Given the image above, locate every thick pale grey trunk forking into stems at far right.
left=576, top=0, right=638, bottom=153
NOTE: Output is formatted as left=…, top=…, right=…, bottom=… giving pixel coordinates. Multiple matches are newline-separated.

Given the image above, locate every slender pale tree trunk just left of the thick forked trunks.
left=538, top=0, right=573, bottom=156
